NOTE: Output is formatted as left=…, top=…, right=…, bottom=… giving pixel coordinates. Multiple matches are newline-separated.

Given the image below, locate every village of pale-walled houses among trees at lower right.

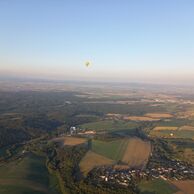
left=92, top=160, right=194, bottom=186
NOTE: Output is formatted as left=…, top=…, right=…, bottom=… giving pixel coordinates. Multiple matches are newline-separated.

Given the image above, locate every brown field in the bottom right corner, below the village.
left=172, top=180, right=194, bottom=194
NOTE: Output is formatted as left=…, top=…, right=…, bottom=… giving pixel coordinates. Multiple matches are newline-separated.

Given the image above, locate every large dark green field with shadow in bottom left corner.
left=0, top=154, right=58, bottom=194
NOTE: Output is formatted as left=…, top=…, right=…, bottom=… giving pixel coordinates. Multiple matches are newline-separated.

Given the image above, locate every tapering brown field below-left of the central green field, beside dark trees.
left=79, top=151, right=114, bottom=175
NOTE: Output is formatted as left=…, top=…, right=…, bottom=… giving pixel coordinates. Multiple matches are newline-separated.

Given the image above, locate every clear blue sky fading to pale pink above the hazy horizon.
left=0, top=0, right=194, bottom=83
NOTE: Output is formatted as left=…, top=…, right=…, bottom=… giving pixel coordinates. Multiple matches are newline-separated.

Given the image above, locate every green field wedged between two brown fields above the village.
left=92, top=139, right=129, bottom=161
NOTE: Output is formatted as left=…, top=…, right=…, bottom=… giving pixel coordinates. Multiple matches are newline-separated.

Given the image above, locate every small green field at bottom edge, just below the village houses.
left=139, top=179, right=178, bottom=194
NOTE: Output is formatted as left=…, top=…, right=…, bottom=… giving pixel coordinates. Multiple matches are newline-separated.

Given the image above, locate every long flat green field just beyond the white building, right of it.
left=80, top=120, right=137, bottom=131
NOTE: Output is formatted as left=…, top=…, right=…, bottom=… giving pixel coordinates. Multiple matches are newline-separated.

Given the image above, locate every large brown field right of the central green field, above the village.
left=122, top=138, right=151, bottom=167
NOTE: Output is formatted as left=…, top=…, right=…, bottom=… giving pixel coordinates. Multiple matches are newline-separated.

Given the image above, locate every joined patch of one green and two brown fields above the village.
left=80, top=138, right=151, bottom=173
